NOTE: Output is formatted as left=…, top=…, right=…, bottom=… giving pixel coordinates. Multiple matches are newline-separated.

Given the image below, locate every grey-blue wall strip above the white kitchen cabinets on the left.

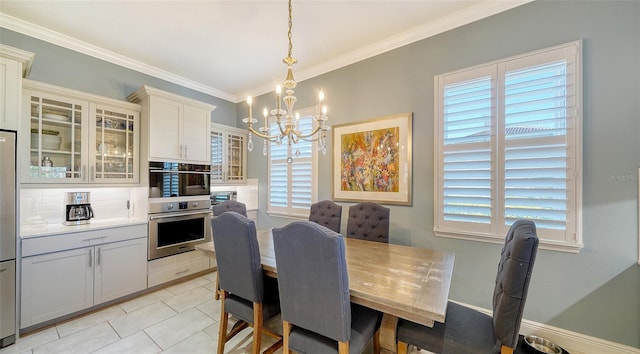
left=0, top=28, right=237, bottom=126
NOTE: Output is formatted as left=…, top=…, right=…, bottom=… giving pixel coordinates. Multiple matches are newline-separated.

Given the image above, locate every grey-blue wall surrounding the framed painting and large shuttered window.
left=244, top=1, right=640, bottom=347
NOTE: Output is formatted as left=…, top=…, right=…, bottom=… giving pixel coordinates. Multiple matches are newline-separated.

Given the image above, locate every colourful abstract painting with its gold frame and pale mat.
left=332, top=113, right=413, bottom=205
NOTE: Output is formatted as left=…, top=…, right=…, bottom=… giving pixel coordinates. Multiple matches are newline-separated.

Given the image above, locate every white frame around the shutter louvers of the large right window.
left=433, top=40, right=583, bottom=253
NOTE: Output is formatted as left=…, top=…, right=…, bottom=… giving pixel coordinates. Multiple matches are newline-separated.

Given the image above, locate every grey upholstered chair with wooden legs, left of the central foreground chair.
left=211, top=212, right=282, bottom=354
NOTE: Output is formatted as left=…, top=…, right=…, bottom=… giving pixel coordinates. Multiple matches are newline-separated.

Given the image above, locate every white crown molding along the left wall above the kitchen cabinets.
left=0, top=13, right=238, bottom=102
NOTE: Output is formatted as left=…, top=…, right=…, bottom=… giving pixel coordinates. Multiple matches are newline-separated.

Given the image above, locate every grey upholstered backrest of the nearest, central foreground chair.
left=273, top=221, right=351, bottom=342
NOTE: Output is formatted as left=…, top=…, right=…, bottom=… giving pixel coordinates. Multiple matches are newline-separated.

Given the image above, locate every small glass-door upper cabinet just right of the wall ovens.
left=211, top=123, right=247, bottom=184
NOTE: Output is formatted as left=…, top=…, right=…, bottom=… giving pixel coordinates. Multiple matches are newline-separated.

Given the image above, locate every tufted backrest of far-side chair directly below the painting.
left=347, top=202, right=389, bottom=243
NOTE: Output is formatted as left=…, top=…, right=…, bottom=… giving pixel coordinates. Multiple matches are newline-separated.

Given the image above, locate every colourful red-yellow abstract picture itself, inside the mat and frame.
left=340, top=127, right=400, bottom=192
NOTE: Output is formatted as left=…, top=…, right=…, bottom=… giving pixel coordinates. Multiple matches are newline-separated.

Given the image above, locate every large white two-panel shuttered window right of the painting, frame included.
left=434, top=41, right=582, bottom=252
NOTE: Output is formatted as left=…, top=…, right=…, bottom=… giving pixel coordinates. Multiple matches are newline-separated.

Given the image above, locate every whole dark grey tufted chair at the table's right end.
left=397, top=220, right=538, bottom=354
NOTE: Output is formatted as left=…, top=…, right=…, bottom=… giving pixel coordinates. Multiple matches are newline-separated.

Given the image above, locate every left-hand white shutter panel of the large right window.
left=436, top=67, right=496, bottom=232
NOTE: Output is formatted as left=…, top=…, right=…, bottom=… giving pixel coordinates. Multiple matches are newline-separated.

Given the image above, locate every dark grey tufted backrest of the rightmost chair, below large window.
left=493, top=220, right=538, bottom=348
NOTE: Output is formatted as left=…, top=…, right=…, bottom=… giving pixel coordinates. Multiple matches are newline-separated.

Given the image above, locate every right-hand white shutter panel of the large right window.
left=502, top=46, right=578, bottom=241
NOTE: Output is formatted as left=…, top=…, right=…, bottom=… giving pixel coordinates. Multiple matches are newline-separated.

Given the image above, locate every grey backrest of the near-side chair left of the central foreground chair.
left=211, top=212, right=264, bottom=302
